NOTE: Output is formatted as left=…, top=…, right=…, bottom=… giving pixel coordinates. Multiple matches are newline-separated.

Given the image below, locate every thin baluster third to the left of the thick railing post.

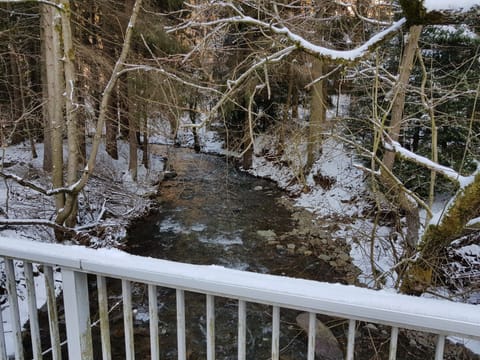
left=5, top=258, right=24, bottom=360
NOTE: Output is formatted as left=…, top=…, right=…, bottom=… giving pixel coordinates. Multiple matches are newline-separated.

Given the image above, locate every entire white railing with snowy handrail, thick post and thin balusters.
left=0, top=238, right=480, bottom=360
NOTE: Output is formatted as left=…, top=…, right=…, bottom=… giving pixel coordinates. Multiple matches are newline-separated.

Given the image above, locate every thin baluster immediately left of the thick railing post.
left=43, top=265, right=62, bottom=360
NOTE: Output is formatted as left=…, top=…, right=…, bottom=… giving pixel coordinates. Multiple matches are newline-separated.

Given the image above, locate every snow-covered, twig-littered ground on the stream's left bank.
left=0, top=143, right=164, bottom=353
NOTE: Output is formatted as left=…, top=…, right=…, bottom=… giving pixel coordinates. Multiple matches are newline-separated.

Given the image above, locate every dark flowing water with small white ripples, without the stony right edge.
left=119, top=149, right=344, bottom=359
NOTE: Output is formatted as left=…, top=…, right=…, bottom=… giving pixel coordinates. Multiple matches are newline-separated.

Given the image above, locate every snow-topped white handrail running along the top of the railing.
left=0, top=237, right=480, bottom=338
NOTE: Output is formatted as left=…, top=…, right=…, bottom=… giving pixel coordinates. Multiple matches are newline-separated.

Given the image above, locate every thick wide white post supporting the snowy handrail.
left=62, top=268, right=93, bottom=360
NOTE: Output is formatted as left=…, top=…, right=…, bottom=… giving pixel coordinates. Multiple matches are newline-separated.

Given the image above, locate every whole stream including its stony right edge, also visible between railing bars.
left=24, top=146, right=479, bottom=360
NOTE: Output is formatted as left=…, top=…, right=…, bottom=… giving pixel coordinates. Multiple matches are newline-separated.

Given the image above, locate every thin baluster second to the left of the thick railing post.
left=23, top=261, right=42, bottom=359
